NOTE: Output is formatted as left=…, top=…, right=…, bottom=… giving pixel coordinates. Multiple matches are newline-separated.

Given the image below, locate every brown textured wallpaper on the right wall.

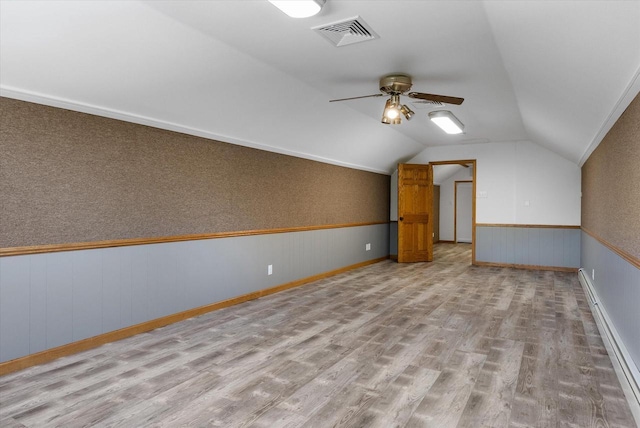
left=582, top=95, right=640, bottom=258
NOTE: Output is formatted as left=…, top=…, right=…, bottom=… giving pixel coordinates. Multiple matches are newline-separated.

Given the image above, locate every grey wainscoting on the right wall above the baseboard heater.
left=581, top=232, right=640, bottom=370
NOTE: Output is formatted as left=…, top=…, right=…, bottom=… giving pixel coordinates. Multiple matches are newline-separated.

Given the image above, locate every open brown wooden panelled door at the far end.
left=398, top=164, right=433, bottom=263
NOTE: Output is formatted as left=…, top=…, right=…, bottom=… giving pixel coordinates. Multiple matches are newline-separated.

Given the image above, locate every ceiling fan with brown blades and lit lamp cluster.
left=329, top=74, right=464, bottom=125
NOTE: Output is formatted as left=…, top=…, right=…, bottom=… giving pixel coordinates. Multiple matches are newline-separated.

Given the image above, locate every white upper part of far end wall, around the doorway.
left=410, top=141, right=581, bottom=226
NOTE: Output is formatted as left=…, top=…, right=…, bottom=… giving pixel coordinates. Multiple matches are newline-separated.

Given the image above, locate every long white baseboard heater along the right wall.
left=578, top=269, right=640, bottom=425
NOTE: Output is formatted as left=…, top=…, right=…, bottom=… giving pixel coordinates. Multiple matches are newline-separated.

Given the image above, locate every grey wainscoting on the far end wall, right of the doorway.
left=476, top=225, right=580, bottom=268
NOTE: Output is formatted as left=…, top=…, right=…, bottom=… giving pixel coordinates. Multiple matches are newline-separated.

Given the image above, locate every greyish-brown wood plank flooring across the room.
left=0, top=244, right=636, bottom=428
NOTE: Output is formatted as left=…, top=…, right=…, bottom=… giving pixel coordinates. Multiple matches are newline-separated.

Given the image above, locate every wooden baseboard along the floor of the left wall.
left=0, top=257, right=389, bottom=376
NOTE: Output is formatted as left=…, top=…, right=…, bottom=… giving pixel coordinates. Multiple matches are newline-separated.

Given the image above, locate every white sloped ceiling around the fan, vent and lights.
left=0, top=0, right=640, bottom=173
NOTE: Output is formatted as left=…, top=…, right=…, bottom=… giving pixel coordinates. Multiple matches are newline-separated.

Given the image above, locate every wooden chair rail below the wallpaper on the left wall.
left=0, top=221, right=389, bottom=257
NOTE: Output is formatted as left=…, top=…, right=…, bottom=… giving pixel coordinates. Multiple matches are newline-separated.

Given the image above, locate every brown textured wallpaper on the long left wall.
left=0, top=98, right=389, bottom=248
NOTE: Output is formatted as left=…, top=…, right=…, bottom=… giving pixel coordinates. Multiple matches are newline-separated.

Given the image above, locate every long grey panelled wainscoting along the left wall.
left=0, top=224, right=389, bottom=362
